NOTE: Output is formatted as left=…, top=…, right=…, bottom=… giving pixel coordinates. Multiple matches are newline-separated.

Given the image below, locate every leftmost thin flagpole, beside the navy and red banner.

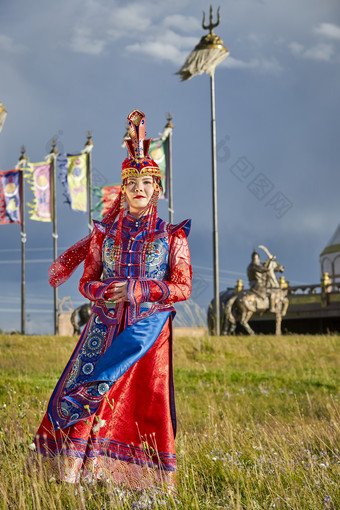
left=17, top=145, right=27, bottom=335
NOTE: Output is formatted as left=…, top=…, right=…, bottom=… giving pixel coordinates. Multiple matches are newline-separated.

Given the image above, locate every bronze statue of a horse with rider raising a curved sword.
left=222, top=245, right=289, bottom=336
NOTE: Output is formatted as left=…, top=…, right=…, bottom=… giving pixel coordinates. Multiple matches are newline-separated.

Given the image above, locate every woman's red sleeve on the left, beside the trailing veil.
left=79, top=231, right=107, bottom=301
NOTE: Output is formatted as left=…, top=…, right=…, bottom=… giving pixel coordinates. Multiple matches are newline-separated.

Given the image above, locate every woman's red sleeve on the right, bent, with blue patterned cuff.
left=128, top=230, right=192, bottom=304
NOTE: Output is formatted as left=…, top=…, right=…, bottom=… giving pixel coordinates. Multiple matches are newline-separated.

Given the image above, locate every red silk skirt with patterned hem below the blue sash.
left=35, top=319, right=176, bottom=488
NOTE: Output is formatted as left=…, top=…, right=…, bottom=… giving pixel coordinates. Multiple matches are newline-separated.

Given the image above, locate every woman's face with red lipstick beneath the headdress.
left=125, top=175, right=154, bottom=215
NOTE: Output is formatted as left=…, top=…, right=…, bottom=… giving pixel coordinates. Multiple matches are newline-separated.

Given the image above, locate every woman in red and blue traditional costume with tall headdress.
left=35, top=110, right=191, bottom=488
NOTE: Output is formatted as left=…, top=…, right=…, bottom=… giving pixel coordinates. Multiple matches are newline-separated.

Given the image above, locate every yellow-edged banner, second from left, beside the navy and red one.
left=24, top=161, right=52, bottom=221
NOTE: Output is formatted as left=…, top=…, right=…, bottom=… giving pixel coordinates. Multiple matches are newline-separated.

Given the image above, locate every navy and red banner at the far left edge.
left=0, top=170, right=21, bottom=225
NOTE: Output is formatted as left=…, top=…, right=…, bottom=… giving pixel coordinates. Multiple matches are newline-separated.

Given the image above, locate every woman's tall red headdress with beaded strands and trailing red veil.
left=48, top=110, right=161, bottom=287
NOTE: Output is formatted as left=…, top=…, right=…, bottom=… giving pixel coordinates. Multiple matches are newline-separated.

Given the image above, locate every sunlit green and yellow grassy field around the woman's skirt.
left=0, top=335, right=340, bottom=510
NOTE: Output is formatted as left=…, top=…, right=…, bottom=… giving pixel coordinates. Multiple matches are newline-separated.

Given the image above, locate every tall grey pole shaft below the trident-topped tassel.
left=210, top=71, right=221, bottom=336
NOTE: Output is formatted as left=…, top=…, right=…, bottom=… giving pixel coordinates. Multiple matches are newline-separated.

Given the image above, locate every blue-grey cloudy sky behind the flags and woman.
left=0, top=0, right=340, bottom=333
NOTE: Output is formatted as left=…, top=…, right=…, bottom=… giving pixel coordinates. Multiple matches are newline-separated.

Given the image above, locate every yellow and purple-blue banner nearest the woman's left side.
left=57, top=153, right=88, bottom=212
